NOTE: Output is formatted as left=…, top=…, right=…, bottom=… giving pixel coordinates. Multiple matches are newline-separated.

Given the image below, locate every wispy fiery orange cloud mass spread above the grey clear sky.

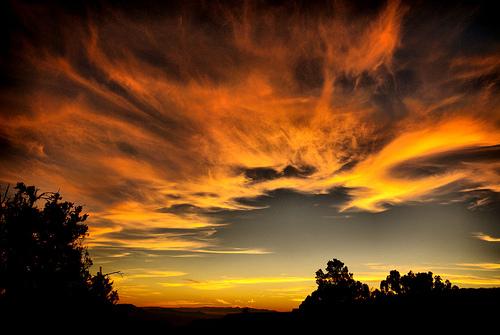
left=0, top=1, right=500, bottom=310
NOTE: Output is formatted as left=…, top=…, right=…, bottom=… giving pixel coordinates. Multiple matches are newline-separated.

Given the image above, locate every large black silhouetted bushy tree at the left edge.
left=0, top=183, right=118, bottom=307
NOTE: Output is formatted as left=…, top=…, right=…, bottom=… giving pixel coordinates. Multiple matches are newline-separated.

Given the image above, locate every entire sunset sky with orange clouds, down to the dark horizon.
left=0, top=1, right=500, bottom=310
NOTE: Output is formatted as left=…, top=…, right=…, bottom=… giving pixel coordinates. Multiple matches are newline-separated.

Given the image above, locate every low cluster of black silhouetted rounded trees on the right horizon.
left=299, top=259, right=458, bottom=311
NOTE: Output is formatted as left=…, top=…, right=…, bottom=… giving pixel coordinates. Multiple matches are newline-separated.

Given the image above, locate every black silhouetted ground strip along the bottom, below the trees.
left=0, top=288, right=500, bottom=334
